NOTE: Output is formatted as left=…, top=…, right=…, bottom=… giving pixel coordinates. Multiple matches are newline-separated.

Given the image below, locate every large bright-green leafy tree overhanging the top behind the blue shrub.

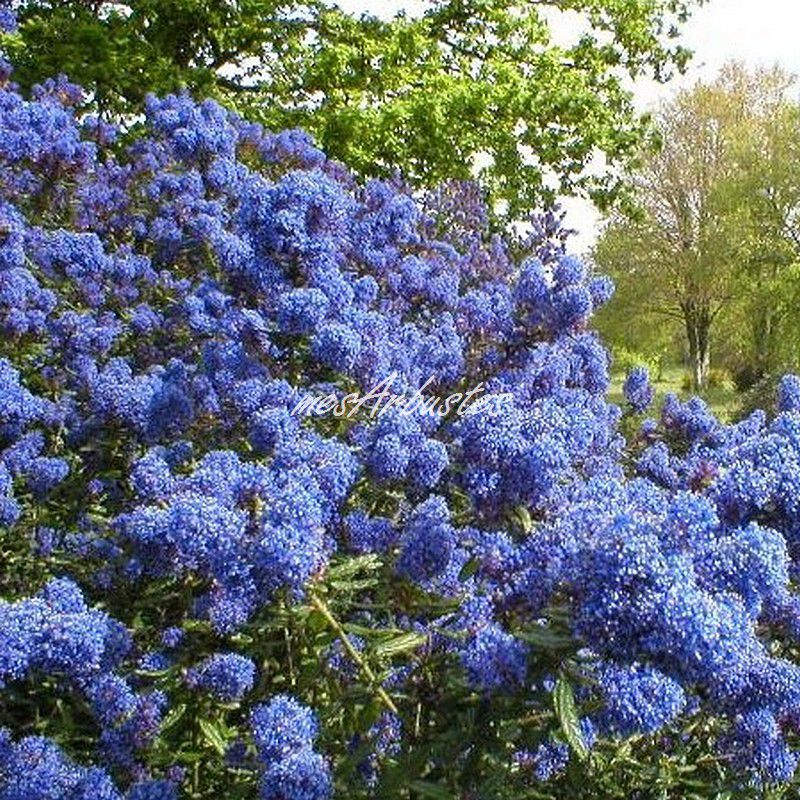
left=0, top=0, right=703, bottom=219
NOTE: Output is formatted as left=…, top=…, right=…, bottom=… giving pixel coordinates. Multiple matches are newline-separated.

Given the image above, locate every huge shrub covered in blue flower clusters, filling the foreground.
left=0, top=9, right=800, bottom=800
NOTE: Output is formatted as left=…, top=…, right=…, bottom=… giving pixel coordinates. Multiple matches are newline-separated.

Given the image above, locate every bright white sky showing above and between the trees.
left=339, top=0, right=800, bottom=252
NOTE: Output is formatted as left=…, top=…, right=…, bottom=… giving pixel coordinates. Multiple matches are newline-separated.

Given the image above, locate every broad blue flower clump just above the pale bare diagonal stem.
left=113, top=444, right=358, bottom=631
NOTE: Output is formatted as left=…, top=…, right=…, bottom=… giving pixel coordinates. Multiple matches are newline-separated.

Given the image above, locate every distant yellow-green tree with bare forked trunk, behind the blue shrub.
left=595, top=64, right=790, bottom=390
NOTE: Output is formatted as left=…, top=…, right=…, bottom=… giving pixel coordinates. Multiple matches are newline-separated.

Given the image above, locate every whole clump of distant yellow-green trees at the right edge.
left=595, top=64, right=800, bottom=389
